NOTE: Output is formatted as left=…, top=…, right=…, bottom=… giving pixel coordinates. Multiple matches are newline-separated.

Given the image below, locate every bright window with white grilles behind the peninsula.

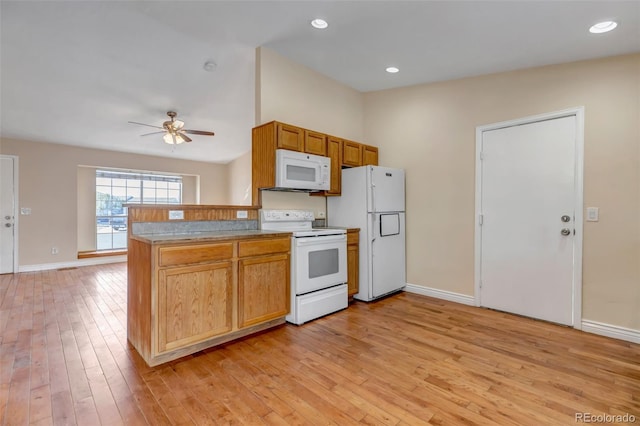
left=96, top=170, right=182, bottom=250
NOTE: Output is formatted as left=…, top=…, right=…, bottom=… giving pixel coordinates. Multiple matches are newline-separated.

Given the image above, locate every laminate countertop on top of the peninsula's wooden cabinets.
left=131, top=229, right=291, bottom=244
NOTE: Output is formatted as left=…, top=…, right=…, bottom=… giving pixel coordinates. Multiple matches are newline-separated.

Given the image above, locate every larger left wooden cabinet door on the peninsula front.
left=156, top=262, right=233, bottom=353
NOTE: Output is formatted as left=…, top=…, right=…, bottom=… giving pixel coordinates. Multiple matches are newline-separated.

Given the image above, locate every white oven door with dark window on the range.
left=292, top=234, right=347, bottom=295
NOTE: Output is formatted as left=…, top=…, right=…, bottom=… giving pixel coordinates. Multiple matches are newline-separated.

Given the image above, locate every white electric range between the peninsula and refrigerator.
left=260, top=209, right=349, bottom=324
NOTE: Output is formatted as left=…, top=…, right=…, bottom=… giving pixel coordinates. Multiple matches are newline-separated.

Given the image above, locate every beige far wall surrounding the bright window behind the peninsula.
left=0, top=139, right=229, bottom=266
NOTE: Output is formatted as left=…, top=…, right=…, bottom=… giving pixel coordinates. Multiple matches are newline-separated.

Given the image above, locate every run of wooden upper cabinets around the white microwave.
left=251, top=121, right=378, bottom=206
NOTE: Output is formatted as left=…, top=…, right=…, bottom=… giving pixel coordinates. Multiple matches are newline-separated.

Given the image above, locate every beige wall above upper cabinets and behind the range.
left=256, top=47, right=364, bottom=214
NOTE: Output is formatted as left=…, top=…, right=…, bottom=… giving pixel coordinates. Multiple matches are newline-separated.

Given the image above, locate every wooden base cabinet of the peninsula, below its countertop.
left=127, top=234, right=291, bottom=366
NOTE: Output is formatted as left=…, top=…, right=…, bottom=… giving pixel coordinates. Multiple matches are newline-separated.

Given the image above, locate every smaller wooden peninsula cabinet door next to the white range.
left=238, top=253, right=290, bottom=328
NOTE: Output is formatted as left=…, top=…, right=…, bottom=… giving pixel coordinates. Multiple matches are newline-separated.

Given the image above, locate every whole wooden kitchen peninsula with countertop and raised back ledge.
left=127, top=204, right=291, bottom=366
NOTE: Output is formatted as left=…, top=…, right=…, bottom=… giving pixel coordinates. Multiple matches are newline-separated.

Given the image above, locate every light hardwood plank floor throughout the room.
left=0, top=264, right=640, bottom=425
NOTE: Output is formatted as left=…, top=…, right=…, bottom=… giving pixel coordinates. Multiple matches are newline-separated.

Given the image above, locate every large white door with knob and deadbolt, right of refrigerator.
left=479, top=116, right=576, bottom=325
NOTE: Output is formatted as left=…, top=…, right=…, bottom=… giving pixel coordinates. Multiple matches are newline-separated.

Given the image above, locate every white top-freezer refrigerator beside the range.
left=327, top=166, right=407, bottom=302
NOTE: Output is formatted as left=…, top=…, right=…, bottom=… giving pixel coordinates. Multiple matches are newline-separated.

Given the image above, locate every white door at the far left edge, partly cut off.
left=0, top=156, right=16, bottom=274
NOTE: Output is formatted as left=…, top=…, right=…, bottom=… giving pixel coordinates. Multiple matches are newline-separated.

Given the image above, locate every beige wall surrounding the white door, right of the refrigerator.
left=364, top=54, right=640, bottom=330
